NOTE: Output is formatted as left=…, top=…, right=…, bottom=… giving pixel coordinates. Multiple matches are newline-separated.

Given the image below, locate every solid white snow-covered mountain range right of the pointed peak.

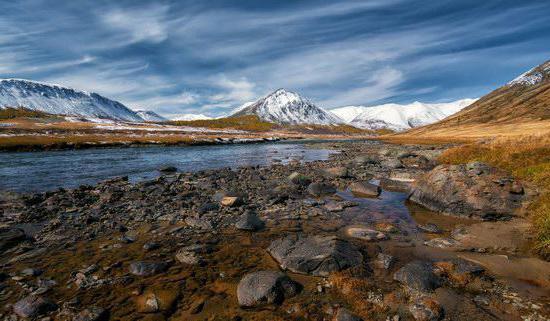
left=331, top=99, right=476, bottom=131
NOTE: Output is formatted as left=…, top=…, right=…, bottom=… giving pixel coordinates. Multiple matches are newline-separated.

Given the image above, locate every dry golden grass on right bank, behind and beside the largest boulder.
left=439, top=135, right=550, bottom=259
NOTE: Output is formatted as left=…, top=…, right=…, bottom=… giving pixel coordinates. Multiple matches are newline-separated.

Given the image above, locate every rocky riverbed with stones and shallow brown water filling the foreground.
left=0, top=142, right=550, bottom=321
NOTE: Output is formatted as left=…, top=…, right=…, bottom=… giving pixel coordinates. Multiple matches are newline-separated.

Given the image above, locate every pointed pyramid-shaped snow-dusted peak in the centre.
left=231, top=89, right=343, bottom=125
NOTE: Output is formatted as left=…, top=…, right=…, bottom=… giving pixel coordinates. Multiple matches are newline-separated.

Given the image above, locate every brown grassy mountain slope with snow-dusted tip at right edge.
left=412, top=60, right=550, bottom=132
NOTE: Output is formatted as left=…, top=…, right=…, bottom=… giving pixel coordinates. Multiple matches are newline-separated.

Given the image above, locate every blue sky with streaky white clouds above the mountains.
left=0, top=0, right=550, bottom=116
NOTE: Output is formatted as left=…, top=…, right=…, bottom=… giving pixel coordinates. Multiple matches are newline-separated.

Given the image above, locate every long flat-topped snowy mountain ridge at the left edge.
left=0, top=79, right=143, bottom=122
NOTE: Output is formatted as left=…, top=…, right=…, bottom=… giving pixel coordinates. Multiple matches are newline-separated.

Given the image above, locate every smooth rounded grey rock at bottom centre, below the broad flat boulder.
left=237, top=271, right=299, bottom=307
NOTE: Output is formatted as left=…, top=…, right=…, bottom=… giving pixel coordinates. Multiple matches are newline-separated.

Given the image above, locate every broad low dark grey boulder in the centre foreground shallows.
left=268, top=235, right=363, bottom=276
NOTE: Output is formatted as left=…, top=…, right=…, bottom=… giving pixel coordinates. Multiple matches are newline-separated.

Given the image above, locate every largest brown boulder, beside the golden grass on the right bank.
left=409, top=163, right=524, bottom=219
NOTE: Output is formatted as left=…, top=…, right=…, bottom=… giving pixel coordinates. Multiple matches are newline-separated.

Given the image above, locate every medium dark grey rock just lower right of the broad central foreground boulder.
left=393, top=261, right=441, bottom=292
